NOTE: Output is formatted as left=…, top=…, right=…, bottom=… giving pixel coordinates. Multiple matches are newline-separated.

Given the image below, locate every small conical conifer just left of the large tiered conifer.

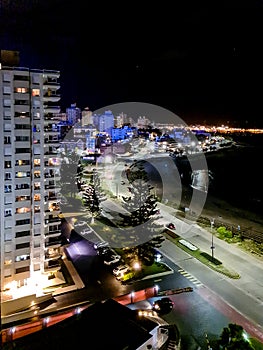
left=82, top=169, right=106, bottom=224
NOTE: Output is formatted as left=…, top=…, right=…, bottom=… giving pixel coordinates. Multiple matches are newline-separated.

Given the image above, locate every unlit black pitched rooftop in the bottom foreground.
left=10, top=299, right=162, bottom=350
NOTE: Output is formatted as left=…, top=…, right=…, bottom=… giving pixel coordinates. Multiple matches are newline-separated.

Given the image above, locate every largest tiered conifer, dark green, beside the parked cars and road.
left=118, top=161, right=164, bottom=265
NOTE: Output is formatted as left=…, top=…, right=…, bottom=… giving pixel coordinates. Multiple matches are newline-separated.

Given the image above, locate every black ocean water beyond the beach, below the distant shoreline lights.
left=131, top=134, right=263, bottom=217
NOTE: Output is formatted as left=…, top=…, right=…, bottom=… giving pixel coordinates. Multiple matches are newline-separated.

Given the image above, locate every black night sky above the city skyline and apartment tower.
left=0, top=0, right=263, bottom=127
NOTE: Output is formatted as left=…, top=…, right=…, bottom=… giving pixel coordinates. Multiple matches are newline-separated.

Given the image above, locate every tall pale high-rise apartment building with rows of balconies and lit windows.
left=0, top=60, right=61, bottom=293
